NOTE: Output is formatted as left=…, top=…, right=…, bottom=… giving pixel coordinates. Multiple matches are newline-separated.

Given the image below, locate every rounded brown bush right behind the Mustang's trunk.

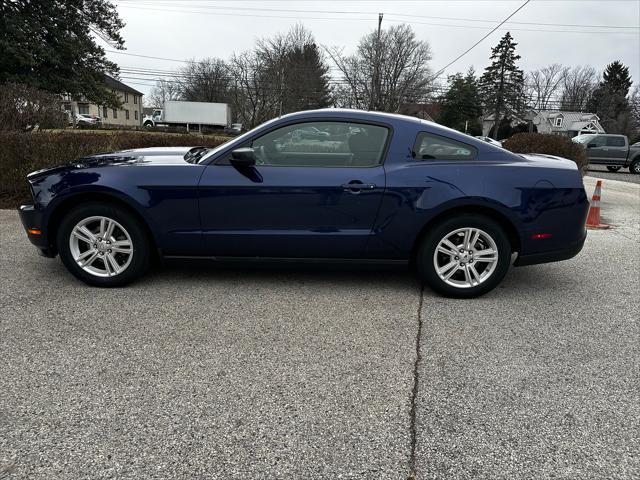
left=502, top=133, right=589, bottom=175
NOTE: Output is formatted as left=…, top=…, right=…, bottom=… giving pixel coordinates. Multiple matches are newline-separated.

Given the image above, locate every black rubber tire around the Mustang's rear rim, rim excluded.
left=416, top=214, right=511, bottom=298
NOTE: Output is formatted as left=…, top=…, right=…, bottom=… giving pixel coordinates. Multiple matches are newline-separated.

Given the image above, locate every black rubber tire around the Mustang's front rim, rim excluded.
left=56, top=202, right=151, bottom=287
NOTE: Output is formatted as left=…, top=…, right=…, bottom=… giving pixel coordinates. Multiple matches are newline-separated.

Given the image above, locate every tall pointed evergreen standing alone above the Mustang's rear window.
left=480, top=32, right=524, bottom=138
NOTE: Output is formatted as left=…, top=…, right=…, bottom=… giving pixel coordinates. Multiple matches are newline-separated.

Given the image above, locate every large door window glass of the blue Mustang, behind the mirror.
left=249, top=122, right=389, bottom=167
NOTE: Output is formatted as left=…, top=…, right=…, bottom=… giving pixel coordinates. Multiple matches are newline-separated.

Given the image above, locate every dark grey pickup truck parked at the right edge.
left=572, top=134, right=640, bottom=174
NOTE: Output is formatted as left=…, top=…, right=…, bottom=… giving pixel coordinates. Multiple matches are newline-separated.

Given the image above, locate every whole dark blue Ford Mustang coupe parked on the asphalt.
left=20, top=109, right=589, bottom=297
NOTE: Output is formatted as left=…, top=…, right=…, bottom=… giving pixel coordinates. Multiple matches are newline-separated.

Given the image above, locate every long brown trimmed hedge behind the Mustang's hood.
left=0, top=131, right=227, bottom=206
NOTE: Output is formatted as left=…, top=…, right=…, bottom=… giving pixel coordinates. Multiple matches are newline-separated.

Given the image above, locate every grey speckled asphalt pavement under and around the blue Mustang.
left=0, top=177, right=640, bottom=480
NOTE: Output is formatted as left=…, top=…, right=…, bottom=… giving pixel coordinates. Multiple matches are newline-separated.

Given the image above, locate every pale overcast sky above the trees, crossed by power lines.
left=107, top=0, right=640, bottom=93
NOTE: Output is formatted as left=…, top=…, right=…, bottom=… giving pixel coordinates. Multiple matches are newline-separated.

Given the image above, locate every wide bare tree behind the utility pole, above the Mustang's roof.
left=326, top=24, right=432, bottom=112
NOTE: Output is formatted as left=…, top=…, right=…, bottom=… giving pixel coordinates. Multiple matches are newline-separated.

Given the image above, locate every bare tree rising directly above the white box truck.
left=177, top=58, right=231, bottom=103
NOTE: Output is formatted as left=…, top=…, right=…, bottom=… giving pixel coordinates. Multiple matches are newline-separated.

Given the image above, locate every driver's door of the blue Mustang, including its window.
left=199, top=121, right=391, bottom=258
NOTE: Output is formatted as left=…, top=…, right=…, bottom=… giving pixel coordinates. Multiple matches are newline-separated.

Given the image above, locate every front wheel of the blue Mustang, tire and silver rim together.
left=57, top=203, right=150, bottom=287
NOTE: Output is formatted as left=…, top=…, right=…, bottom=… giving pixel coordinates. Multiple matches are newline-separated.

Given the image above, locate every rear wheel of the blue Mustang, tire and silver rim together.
left=417, top=214, right=511, bottom=298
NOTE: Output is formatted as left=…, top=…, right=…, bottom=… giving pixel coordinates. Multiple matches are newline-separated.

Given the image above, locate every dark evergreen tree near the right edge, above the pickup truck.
left=587, top=60, right=633, bottom=134
